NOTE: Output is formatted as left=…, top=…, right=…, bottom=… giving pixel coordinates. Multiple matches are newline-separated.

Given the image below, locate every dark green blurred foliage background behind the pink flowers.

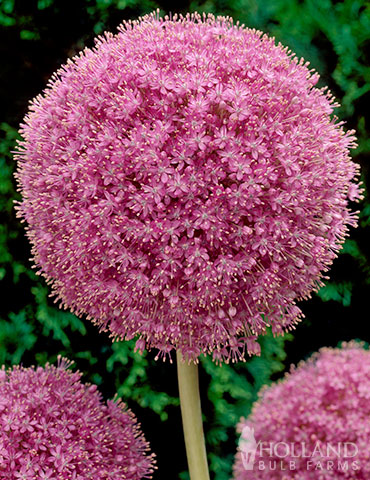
left=0, top=0, right=370, bottom=480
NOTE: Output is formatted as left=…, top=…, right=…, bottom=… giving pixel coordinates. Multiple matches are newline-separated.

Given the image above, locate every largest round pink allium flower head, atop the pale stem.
left=17, top=14, right=359, bottom=360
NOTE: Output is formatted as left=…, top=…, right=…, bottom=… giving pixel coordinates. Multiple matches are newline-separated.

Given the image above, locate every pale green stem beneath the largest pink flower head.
left=177, top=352, right=209, bottom=480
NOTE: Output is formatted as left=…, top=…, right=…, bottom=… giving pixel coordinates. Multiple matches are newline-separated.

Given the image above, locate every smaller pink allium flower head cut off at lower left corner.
left=0, top=360, right=153, bottom=480
